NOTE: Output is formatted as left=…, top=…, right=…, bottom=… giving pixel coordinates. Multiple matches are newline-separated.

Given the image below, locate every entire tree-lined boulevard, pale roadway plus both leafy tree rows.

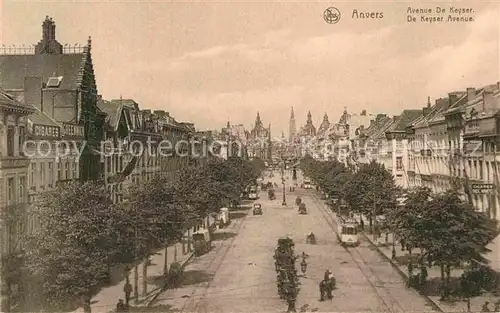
left=5, top=156, right=498, bottom=312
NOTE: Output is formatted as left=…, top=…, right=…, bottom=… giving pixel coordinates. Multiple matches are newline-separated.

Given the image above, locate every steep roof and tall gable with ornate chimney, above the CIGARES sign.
left=0, top=17, right=103, bottom=180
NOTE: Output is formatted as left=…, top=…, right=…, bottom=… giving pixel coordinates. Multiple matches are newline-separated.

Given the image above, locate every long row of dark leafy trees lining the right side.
left=301, top=157, right=500, bottom=311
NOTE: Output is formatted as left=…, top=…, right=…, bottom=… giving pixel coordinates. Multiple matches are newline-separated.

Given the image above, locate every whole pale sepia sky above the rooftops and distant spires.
left=0, top=0, right=500, bottom=136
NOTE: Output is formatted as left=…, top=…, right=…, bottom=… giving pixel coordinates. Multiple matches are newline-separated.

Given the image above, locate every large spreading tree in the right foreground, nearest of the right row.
left=388, top=187, right=498, bottom=298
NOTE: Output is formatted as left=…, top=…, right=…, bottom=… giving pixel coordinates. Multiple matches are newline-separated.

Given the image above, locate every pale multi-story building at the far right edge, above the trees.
left=446, top=83, right=500, bottom=218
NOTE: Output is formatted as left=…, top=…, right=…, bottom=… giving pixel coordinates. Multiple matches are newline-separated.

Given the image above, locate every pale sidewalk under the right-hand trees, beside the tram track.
left=355, top=211, right=500, bottom=312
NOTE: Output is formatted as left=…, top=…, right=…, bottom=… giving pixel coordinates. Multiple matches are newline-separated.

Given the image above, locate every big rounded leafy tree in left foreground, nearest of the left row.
left=26, top=181, right=117, bottom=312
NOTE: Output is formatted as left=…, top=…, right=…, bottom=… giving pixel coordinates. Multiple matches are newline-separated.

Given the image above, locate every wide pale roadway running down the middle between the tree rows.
left=149, top=174, right=438, bottom=312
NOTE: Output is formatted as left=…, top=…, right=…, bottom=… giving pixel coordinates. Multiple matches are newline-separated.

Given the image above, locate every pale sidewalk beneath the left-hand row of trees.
left=72, top=219, right=214, bottom=313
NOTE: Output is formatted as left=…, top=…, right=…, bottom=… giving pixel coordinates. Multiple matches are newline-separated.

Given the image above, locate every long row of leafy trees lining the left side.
left=4, top=157, right=263, bottom=312
